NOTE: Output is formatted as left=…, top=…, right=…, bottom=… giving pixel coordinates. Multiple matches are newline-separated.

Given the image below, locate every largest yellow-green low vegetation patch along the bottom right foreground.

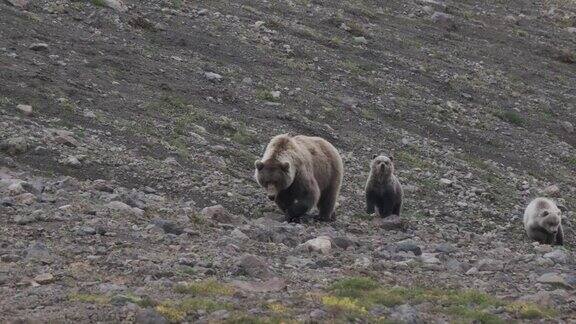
left=319, top=277, right=554, bottom=323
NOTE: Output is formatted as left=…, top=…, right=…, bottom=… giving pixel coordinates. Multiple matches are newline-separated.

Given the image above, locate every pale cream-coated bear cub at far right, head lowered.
left=524, top=197, right=564, bottom=245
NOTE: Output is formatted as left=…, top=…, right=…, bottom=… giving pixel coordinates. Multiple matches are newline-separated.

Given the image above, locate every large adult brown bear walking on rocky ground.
left=254, top=134, right=343, bottom=222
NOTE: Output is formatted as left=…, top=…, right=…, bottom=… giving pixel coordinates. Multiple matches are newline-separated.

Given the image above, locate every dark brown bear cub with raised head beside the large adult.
left=366, top=154, right=404, bottom=217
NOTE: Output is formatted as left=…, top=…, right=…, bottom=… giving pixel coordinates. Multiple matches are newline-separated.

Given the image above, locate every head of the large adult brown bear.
left=254, top=159, right=295, bottom=200
